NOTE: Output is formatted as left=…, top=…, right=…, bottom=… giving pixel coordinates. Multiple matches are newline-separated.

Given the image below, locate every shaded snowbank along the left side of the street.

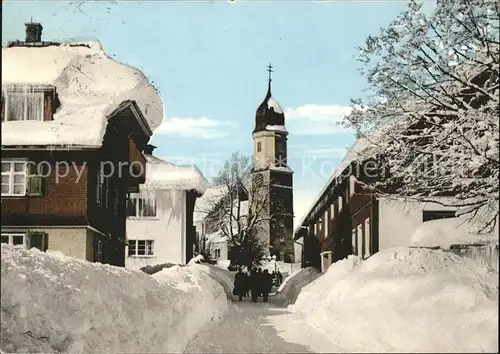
left=0, top=244, right=228, bottom=353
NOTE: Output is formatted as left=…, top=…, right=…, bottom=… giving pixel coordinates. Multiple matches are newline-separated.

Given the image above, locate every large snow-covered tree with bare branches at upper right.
left=345, top=0, right=500, bottom=229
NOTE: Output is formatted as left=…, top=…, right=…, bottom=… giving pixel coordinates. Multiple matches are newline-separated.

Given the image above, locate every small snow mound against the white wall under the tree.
left=410, top=217, right=498, bottom=249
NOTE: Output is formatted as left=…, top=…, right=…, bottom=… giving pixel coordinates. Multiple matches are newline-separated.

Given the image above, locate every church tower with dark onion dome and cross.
left=250, top=64, right=294, bottom=262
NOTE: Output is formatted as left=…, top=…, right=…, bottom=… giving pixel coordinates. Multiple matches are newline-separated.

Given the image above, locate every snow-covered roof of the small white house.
left=140, top=155, right=208, bottom=194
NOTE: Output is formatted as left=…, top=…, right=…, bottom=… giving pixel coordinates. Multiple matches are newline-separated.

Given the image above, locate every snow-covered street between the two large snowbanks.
left=185, top=297, right=341, bottom=353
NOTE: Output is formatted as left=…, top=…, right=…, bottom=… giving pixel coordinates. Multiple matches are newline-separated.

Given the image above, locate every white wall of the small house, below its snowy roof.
left=125, top=190, right=186, bottom=269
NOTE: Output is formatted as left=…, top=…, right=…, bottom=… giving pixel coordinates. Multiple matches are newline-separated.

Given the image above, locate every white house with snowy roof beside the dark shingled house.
left=125, top=151, right=208, bottom=269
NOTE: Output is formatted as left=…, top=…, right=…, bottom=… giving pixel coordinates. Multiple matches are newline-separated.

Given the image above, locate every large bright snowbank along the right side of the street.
left=290, top=248, right=498, bottom=352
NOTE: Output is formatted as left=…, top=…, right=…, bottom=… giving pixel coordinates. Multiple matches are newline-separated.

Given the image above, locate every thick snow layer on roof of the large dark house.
left=2, top=42, right=163, bottom=147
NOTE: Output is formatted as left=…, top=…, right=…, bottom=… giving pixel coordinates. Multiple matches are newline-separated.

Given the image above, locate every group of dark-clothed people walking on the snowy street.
left=233, top=267, right=281, bottom=302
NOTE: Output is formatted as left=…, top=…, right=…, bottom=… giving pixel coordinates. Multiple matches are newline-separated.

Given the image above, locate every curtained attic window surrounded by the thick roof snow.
left=5, top=91, right=44, bottom=121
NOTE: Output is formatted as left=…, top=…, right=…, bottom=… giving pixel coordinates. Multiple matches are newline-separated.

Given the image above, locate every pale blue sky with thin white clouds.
left=2, top=0, right=434, bottom=224
